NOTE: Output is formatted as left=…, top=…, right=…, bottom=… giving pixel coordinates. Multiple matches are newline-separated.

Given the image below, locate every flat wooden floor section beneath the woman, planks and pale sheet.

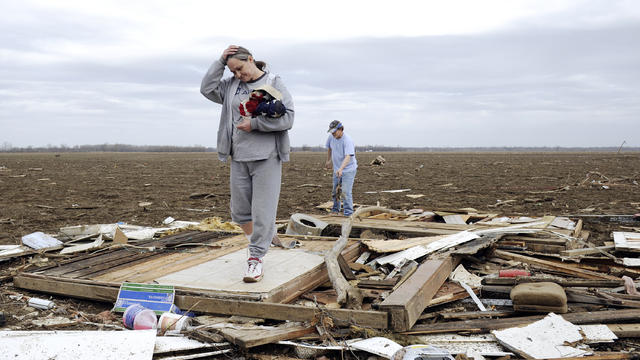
left=15, top=232, right=360, bottom=302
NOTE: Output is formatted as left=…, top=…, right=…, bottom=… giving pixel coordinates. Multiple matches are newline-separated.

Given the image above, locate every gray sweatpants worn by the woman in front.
left=230, top=156, right=282, bottom=258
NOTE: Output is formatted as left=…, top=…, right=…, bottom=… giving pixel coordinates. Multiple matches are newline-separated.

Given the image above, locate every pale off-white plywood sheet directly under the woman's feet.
left=155, top=248, right=324, bottom=294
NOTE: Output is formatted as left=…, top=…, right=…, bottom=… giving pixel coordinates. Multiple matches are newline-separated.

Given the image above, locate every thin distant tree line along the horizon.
left=0, top=141, right=640, bottom=153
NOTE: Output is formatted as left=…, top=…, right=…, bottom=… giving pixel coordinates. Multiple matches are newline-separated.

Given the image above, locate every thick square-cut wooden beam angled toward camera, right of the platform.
left=380, top=257, right=454, bottom=331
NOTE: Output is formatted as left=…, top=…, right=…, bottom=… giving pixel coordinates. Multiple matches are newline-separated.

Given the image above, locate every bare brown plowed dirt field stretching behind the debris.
left=0, top=152, right=640, bottom=356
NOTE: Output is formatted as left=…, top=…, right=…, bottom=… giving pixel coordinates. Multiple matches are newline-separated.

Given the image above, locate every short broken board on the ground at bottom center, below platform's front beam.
left=218, top=323, right=316, bottom=349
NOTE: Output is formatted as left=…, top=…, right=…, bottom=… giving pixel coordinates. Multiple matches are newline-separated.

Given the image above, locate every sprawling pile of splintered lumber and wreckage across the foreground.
left=0, top=207, right=640, bottom=359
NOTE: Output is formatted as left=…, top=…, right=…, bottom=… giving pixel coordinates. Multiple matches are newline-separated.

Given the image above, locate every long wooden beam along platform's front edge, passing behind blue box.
left=14, top=273, right=388, bottom=329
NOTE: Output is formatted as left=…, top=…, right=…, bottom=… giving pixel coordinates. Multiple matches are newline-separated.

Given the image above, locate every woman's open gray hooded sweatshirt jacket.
left=200, top=59, right=294, bottom=161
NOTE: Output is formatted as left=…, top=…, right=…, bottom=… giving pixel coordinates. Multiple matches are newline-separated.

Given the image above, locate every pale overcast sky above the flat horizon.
left=0, top=0, right=640, bottom=147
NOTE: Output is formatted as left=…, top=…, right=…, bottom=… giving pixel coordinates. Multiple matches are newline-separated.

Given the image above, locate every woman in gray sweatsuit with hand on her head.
left=200, top=45, right=294, bottom=282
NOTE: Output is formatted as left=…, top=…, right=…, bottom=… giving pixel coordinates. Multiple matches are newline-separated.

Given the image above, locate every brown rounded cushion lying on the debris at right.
left=510, top=282, right=567, bottom=308
